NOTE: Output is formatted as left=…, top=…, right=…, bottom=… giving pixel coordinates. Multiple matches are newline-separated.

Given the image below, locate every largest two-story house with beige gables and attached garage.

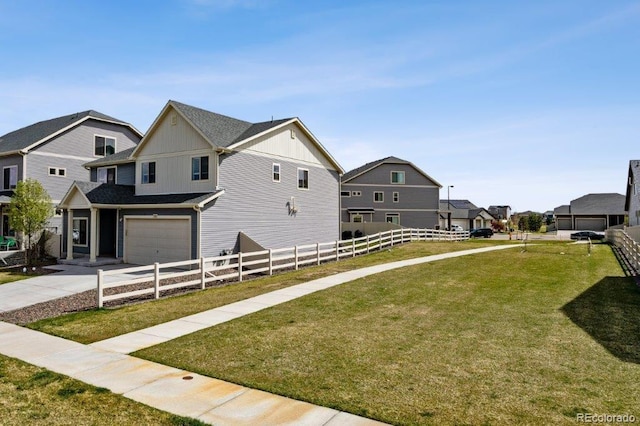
left=59, top=101, right=343, bottom=264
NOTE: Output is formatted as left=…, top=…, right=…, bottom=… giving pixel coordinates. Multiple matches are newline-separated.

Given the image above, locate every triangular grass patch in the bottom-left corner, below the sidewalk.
left=0, top=355, right=203, bottom=426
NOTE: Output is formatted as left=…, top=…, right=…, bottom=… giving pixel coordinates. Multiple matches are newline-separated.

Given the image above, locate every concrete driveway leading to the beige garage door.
left=0, top=264, right=131, bottom=313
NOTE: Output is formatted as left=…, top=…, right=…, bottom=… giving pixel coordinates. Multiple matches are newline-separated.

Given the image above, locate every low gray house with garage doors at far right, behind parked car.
left=553, top=193, right=625, bottom=232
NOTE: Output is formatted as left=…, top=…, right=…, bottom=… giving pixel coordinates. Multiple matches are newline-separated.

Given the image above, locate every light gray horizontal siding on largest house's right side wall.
left=201, top=152, right=340, bottom=257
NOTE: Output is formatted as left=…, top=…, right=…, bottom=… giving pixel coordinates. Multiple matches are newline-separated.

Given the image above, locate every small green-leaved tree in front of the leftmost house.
left=9, top=179, right=53, bottom=263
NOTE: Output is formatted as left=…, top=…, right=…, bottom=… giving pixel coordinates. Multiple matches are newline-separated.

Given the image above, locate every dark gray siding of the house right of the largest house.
left=341, top=163, right=440, bottom=228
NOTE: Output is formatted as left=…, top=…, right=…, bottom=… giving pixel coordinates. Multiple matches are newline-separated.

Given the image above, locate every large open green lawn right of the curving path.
left=127, top=243, right=640, bottom=424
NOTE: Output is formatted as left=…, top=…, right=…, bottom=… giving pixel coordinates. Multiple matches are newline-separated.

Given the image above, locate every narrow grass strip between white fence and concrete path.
left=28, top=239, right=510, bottom=344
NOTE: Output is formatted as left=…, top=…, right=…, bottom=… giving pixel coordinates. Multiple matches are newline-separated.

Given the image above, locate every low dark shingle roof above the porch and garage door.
left=75, top=181, right=220, bottom=206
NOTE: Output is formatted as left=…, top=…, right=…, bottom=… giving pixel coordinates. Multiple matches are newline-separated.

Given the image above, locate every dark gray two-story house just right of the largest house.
left=340, top=157, right=442, bottom=229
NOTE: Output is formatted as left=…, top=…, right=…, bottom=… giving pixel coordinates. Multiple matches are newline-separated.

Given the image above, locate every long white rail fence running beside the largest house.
left=97, top=228, right=469, bottom=308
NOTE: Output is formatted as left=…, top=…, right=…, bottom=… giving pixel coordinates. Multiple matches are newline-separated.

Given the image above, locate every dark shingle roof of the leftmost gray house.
left=0, top=110, right=129, bottom=153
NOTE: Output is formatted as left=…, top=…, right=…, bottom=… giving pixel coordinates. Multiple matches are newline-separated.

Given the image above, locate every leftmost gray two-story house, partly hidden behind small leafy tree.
left=0, top=111, right=142, bottom=235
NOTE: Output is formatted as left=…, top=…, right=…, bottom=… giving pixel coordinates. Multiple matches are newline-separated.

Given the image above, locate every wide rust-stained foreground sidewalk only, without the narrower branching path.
left=0, top=322, right=383, bottom=426
